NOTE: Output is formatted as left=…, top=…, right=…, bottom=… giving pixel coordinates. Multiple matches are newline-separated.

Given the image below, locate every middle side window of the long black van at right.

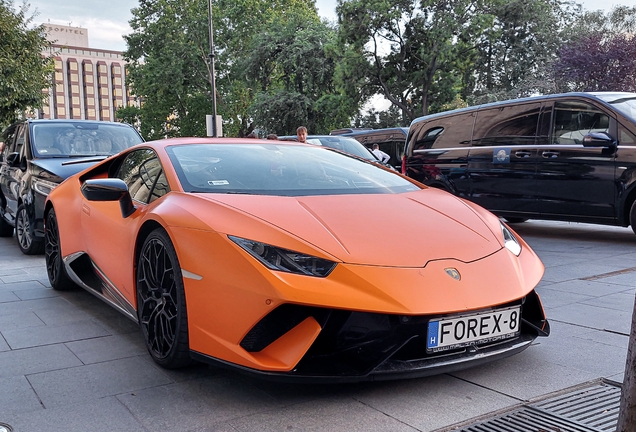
left=473, top=103, right=541, bottom=146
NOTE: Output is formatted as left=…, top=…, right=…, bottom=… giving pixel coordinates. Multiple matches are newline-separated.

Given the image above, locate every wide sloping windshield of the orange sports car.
left=167, top=144, right=419, bottom=196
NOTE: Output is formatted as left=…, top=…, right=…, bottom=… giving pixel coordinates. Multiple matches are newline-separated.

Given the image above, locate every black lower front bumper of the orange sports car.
left=192, top=291, right=550, bottom=382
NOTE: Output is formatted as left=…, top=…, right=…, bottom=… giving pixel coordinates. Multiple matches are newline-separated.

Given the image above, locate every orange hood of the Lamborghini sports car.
left=201, top=188, right=502, bottom=267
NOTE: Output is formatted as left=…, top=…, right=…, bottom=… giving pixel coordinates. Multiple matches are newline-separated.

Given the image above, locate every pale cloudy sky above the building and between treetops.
left=28, top=0, right=636, bottom=51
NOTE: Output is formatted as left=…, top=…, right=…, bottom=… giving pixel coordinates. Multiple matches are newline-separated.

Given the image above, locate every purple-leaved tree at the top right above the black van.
left=553, top=7, right=636, bottom=92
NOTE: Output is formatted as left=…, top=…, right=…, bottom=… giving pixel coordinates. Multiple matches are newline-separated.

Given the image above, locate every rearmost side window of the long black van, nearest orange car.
left=407, top=111, right=475, bottom=154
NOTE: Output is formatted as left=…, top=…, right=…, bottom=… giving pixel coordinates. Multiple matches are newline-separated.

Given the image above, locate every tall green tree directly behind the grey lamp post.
left=124, top=0, right=317, bottom=139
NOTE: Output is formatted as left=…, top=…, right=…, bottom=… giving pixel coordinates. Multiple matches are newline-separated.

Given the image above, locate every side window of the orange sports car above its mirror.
left=115, top=149, right=170, bottom=204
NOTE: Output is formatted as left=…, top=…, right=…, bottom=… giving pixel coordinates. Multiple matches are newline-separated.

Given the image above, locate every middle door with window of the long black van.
left=468, top=101, right=542, bottom=217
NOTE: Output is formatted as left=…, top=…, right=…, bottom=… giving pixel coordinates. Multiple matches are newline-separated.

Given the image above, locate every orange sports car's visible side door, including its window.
left=81, top=149, right=169, bottom=305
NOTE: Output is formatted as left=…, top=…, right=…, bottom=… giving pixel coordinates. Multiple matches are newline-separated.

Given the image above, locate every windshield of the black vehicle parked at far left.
left=31, top=121, right=143, bottom=158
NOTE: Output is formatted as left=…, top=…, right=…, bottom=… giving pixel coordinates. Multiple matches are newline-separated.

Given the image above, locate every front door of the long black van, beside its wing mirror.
left=536, top=99, right=616, bottom=222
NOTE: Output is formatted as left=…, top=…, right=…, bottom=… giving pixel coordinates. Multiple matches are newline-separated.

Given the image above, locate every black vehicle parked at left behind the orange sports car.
left=0, top=120, right=143, bottom=255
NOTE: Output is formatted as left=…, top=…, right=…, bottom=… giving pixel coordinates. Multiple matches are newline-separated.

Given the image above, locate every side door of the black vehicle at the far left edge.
left=0, top=123, right=27, bottom=224
